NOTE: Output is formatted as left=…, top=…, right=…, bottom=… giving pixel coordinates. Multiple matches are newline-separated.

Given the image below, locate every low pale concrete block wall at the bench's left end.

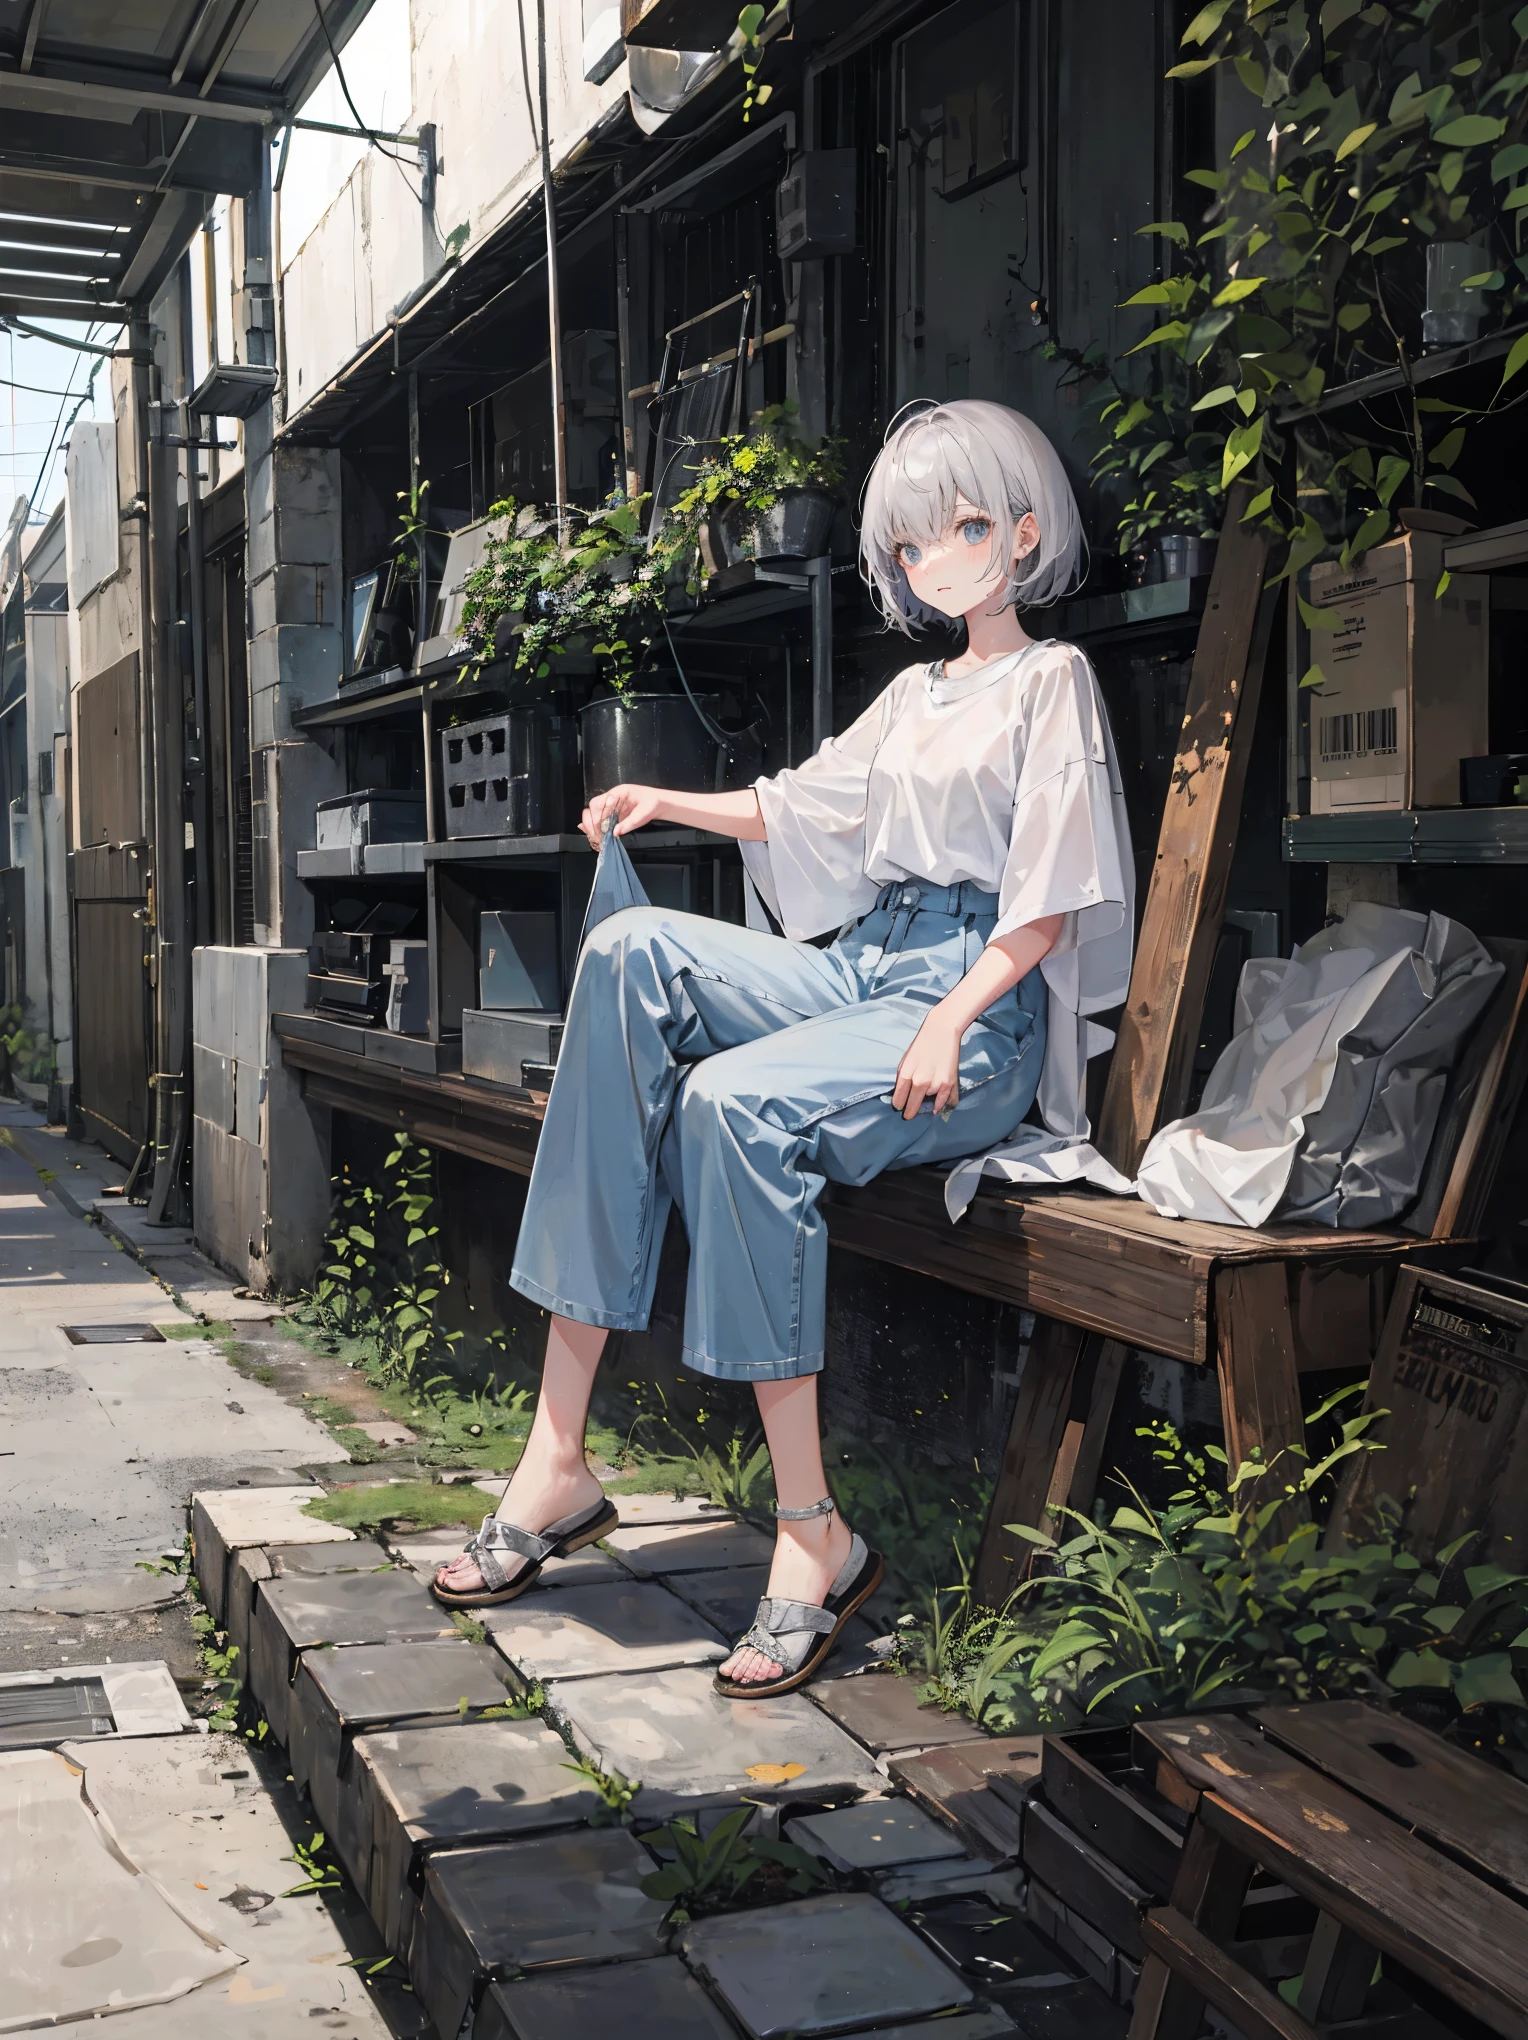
left=192, top=949, right=328, bottom=1295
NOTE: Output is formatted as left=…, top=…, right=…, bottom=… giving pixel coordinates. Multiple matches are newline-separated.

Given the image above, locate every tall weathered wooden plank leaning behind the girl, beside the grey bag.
left=1098, top=483, right=1275, bottom=1175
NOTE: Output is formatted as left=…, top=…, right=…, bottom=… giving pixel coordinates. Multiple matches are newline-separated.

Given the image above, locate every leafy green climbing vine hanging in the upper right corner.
left=1093, top=0, right=1528, bottom=573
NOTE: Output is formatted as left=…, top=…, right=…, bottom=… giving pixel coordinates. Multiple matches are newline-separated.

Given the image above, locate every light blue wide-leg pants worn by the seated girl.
left=510, top=859, right=1045, bottom=1381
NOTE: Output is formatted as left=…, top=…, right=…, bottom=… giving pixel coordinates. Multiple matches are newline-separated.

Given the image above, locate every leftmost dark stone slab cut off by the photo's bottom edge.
left=473, top=1954, right=738, bottom=2040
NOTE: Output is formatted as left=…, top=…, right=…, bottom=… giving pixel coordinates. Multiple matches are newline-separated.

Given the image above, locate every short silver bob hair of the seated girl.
left=859, top=398, right=1085, bottom=630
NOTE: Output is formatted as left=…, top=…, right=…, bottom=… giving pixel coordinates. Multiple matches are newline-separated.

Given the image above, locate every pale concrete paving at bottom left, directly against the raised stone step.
left=61, top=1734, right=388, bottom=2040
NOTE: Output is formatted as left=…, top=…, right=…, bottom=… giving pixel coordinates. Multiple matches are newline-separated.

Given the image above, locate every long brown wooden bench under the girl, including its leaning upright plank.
left=273, top=486, right=1528, bottom=1603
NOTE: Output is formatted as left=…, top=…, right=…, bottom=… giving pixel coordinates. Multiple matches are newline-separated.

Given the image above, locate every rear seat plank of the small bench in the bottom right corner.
left=1248, top=1699, right=1528, bottom=1901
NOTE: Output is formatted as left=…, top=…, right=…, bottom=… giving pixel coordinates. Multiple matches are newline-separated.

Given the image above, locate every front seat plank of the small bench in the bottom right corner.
left=1200, top=1767, right=1528, bottom=2040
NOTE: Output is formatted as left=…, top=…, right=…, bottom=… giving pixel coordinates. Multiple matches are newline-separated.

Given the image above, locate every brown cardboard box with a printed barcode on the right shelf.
left=1308, top=530, right=1491, bottom=814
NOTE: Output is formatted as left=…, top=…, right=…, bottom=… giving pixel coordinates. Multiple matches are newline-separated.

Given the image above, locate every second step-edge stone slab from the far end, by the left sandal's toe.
left=249, top=1573, right=457, bottom=1750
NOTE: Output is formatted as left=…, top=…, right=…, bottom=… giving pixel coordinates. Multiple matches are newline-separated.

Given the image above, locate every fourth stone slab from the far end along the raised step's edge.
left=351, top=1722, right=600, bottom=1958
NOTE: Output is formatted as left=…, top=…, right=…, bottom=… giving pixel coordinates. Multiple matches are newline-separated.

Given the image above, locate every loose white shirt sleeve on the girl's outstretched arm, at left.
left=741, top=679, right=902, bottom=942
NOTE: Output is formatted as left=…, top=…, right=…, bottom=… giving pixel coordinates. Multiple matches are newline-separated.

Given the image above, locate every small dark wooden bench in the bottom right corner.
left=1130, top=1701, right=1528, bottom=2040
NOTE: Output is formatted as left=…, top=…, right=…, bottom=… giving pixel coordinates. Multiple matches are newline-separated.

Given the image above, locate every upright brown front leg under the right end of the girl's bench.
left=1216, top=1261, right=1308, bottom=1518
